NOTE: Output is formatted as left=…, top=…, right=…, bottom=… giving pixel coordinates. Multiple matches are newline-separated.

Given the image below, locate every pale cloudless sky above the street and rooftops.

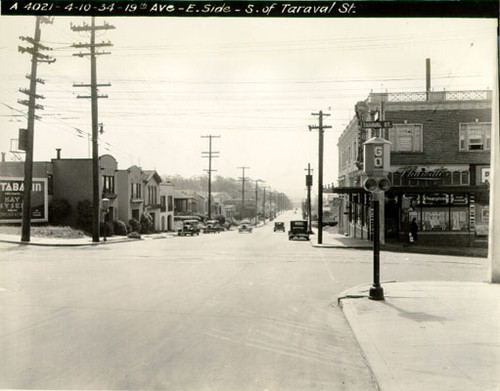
left=0, top=12, right=498, bottom=200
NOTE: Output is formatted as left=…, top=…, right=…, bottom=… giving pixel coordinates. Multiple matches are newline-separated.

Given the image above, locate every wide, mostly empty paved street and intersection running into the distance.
left=0, top=214, right=487, bottom=390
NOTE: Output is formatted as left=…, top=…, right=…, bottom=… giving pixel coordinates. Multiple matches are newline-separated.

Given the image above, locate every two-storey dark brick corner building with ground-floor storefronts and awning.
left=334, top=91, right=492, bottom=246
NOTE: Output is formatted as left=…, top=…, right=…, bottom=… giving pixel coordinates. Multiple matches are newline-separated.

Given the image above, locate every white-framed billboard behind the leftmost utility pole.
left=0, top=177, right=49, bottom=223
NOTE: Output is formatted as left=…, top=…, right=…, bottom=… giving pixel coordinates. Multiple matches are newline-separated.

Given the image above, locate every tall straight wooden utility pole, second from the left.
left=71, top=16, right=115, bottom=242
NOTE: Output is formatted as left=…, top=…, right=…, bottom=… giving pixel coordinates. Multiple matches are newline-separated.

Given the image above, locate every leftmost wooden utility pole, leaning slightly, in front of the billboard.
left=18, top=16, right=55, bottom=242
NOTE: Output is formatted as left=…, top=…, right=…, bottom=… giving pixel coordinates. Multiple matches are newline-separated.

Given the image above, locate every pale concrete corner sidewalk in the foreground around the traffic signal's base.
left=339, top=281, right=500, bottom=391
